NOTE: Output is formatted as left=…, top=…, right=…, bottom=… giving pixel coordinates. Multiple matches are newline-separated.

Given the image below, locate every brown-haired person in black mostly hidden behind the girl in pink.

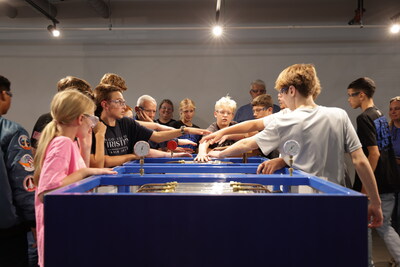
left=31, top=76, right=94, bottom=154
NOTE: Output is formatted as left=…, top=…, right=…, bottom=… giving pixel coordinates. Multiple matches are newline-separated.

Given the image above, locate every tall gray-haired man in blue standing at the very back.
left=233, top=79, right=280, bottom=122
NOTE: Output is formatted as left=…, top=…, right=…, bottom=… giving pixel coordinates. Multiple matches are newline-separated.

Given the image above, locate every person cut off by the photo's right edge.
left=389, top=96, right=400, bottom=237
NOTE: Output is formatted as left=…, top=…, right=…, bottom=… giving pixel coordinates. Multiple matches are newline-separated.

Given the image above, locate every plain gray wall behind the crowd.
left=0, top=31, right=400, bottom=132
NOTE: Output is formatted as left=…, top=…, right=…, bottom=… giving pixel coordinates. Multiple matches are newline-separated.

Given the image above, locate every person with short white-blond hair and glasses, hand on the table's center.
left=194, top=96, right=236, bottom=162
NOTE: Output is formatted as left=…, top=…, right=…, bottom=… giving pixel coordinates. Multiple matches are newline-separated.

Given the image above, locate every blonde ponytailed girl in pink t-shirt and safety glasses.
left=34, top=90, right=116, bottom=267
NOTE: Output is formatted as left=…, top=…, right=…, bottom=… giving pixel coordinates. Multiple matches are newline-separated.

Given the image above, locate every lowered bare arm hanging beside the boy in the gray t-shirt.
left=350, top=148, right=383, bottom=228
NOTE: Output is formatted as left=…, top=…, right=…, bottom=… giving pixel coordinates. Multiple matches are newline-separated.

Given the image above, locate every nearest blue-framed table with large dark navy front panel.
left=44, top=172, right=367, bottom=267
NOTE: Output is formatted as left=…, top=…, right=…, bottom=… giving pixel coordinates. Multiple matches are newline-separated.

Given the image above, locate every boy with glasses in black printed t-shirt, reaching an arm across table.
left=91, top=84, right=209, bottom=167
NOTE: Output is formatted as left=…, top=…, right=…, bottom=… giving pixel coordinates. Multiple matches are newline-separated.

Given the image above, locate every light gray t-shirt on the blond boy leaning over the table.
left=252, top=106, right=361, bottom=185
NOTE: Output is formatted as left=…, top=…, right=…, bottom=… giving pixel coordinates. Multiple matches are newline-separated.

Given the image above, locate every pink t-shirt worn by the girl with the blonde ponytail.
left=35, top=136, right=86, bottom=267
